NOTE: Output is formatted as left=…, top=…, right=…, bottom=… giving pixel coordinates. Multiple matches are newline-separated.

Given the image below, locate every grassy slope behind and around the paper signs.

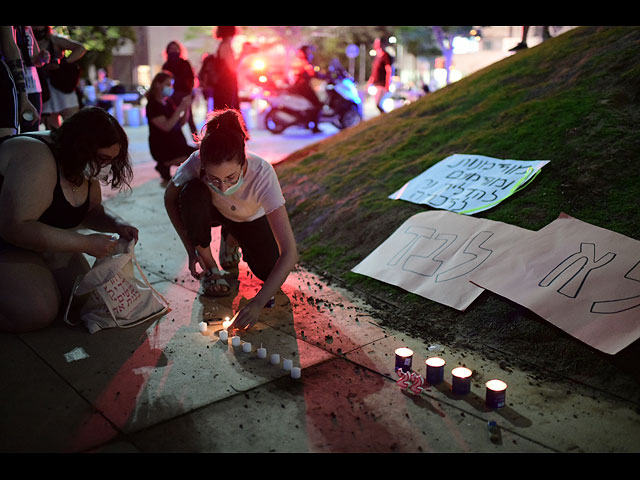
left=276, top=27, right=640, bottom=384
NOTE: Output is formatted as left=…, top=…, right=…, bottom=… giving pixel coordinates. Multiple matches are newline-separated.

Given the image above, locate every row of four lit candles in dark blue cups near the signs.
left=395, top=347, right=507, bottom=408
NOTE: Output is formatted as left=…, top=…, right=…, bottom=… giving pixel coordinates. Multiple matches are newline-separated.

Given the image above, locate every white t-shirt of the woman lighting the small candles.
left=171, top=150, right=285, bottom=222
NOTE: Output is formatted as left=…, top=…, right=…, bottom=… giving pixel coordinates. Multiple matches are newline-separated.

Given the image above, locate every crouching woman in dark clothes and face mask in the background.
left=146, top=71, right=196, bottom=186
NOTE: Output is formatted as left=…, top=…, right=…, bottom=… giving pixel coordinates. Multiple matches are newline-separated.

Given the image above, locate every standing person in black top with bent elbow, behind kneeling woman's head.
left=31, top=26, right=87, bottom=129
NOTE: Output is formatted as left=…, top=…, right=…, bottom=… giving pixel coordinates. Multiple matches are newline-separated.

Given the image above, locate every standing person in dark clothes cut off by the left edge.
left=0, top=26, right=38, bottom=138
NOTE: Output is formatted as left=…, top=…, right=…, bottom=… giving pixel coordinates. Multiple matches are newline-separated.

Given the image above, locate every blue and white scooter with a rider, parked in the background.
left=263, top=70, right=362, bottom=134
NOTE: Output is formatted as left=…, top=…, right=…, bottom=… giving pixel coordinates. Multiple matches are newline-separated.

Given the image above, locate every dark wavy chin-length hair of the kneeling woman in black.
left=51, top=107, right=133, bottom=190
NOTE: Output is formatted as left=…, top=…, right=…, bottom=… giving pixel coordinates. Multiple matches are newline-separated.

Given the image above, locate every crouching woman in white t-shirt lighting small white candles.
left=165, top=109, right=298, bottom=329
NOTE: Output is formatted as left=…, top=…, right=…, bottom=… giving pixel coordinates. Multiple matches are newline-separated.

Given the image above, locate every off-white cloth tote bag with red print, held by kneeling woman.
left=64, top=239, right=170, bottom=333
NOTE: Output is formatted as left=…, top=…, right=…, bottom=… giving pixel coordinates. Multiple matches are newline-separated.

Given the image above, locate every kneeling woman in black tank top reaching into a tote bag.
left=0, top=107, right=138, bottom=332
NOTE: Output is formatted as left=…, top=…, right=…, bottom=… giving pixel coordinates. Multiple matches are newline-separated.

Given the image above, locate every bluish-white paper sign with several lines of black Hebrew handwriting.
left=389, top=153, right=549, bottom=215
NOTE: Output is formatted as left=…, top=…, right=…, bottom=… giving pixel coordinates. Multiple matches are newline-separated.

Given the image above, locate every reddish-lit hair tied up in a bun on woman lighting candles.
left=196, top=108, right=249, bottom=166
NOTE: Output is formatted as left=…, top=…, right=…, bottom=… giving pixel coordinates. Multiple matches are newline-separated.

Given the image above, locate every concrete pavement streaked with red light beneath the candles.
left=0, top=117, right=640, bottom=453
